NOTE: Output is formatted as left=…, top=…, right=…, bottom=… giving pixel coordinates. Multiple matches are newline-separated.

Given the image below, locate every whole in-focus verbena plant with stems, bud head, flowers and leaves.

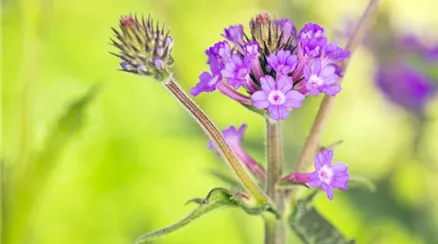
left=112, top=0, right=378, bottom=244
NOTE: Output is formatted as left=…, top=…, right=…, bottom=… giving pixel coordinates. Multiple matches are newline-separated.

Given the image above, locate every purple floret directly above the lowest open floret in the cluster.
left=268, top=50, right=298, bottom=75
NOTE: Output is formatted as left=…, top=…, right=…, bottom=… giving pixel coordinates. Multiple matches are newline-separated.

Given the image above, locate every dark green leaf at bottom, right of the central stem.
left=288, top=191, right=354, bottom=244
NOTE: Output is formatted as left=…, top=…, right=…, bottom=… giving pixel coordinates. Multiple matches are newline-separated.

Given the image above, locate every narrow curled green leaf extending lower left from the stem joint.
left=134, top=187, right=272, bottom=244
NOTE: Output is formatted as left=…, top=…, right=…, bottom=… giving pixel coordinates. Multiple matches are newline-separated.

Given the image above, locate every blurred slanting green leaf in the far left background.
left=6, top=87, right=97, bottom=243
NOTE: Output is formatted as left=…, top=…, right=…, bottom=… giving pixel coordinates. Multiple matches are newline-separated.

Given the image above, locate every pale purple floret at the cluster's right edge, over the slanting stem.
left=304, top=58, right=341, bottom=96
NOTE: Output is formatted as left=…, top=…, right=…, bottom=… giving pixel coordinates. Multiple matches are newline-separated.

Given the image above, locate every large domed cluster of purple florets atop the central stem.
left=190, top=13, right=349, bottom=120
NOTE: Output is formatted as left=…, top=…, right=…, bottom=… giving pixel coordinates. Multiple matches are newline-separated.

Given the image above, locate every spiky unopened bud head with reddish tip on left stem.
left=111, top=15, right=173, bottom=81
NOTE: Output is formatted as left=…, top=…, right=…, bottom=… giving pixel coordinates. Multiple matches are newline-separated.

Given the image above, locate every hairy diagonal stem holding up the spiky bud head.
left=165, top=78, right=272, bottom=205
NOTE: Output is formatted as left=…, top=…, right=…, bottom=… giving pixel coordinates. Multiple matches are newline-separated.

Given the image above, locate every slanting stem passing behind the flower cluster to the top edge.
left=296, top=0, right=379, bottom=171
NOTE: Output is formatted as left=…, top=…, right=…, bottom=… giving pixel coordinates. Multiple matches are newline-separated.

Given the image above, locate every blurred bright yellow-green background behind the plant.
left=1, top=0, right=438, bottom=244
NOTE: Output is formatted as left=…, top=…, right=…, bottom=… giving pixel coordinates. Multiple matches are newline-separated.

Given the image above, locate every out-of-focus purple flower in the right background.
left=341, top=13, right=438, bottom=117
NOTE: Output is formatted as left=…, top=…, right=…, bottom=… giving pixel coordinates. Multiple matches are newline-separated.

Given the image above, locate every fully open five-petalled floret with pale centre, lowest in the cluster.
left=251, top=75, right=304, bottom=120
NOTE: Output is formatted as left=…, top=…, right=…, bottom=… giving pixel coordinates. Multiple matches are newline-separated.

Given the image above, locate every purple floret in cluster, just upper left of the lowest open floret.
left=221, top=54, right=252, bottom=89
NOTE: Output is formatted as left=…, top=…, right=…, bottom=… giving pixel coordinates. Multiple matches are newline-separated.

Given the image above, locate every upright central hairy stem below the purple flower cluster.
left=265, top=118, right=286, bottom=244
